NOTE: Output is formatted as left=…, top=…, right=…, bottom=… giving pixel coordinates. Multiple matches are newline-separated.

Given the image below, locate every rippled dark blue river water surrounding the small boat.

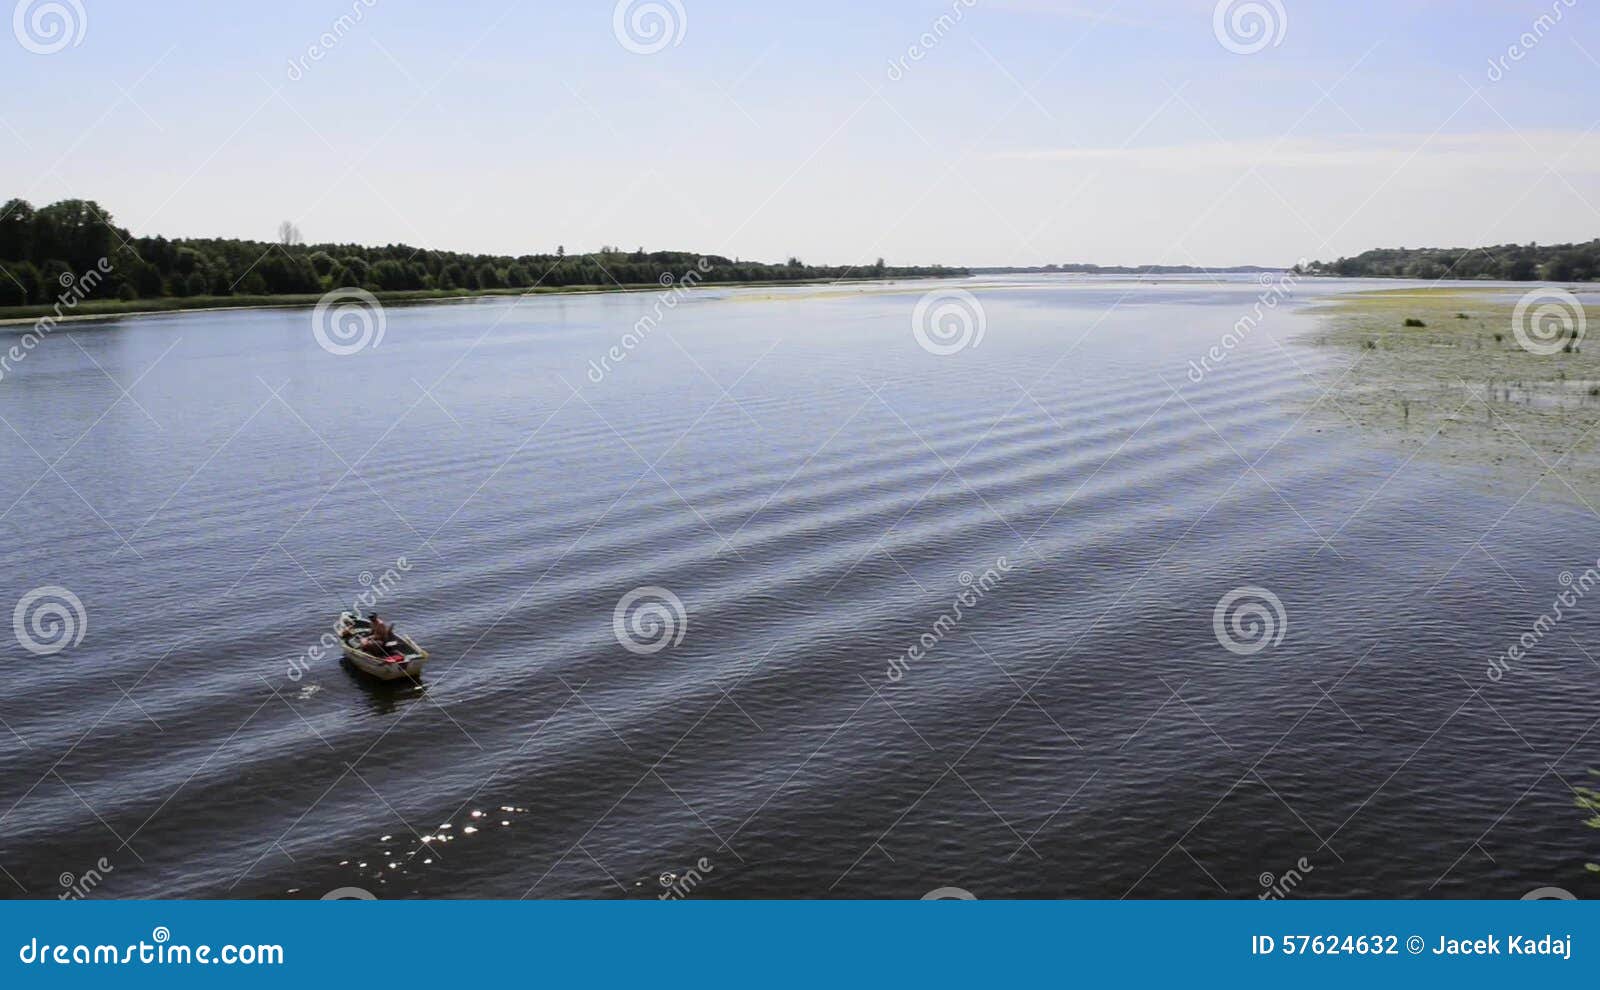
left=0, top=278, right=1600, bottom=897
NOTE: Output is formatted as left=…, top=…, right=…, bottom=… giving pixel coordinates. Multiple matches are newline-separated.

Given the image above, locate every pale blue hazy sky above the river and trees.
left=0, top=0, right=1600, bottom=265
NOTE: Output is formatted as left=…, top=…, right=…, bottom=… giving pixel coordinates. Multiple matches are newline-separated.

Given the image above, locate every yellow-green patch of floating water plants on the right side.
left=1312, top=286, right=1600, bottom=507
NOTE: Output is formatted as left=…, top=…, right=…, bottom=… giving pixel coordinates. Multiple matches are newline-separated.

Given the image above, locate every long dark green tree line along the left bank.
left=0, top=198, right=966, bottom=305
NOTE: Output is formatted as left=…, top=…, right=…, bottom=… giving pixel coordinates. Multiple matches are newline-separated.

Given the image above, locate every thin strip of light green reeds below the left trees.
left=0, top=273, right=966, bottom=328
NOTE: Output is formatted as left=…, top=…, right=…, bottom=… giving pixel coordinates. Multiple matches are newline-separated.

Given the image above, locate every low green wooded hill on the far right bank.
left=1296, top=240, right=1600, bottom=281
